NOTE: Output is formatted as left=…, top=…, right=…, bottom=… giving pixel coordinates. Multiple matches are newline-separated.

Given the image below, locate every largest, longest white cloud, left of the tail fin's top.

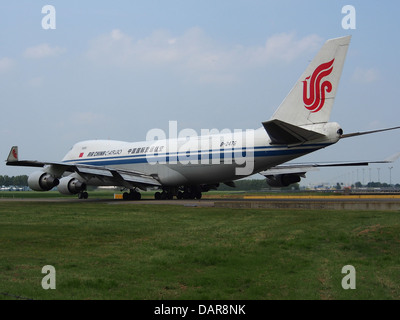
left=86, top=27, right=322, bottom=83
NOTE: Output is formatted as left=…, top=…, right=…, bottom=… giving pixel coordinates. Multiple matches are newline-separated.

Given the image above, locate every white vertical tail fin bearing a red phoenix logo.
left=271, top=36, right=351, bottom=126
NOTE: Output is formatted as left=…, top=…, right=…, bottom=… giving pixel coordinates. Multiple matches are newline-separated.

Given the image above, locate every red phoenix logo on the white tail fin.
left=303, top=59, right=335, bottom=112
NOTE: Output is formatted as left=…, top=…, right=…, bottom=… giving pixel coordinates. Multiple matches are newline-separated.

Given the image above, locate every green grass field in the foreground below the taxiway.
left=0, top=201, right=400, bottom=300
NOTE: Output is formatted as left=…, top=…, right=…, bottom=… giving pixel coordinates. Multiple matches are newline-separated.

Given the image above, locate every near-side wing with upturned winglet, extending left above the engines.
left=6, top=147, right=161, bottom=189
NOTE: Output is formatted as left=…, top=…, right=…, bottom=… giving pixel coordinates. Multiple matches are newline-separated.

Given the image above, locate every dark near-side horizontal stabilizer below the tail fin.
left=262, top=119, right=324, bottom=145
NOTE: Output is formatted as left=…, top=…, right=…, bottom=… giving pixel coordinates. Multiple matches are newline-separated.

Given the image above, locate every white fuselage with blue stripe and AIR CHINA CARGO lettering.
left=62, top=123, right=339, bottom=186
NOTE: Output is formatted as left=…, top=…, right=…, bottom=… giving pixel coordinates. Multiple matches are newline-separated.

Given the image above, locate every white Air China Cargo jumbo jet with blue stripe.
left=6, top=36, right=400, bottom=200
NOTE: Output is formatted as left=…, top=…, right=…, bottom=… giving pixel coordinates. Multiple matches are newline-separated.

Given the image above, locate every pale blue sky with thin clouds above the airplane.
left=0, top=0, right=400, bottom=185
